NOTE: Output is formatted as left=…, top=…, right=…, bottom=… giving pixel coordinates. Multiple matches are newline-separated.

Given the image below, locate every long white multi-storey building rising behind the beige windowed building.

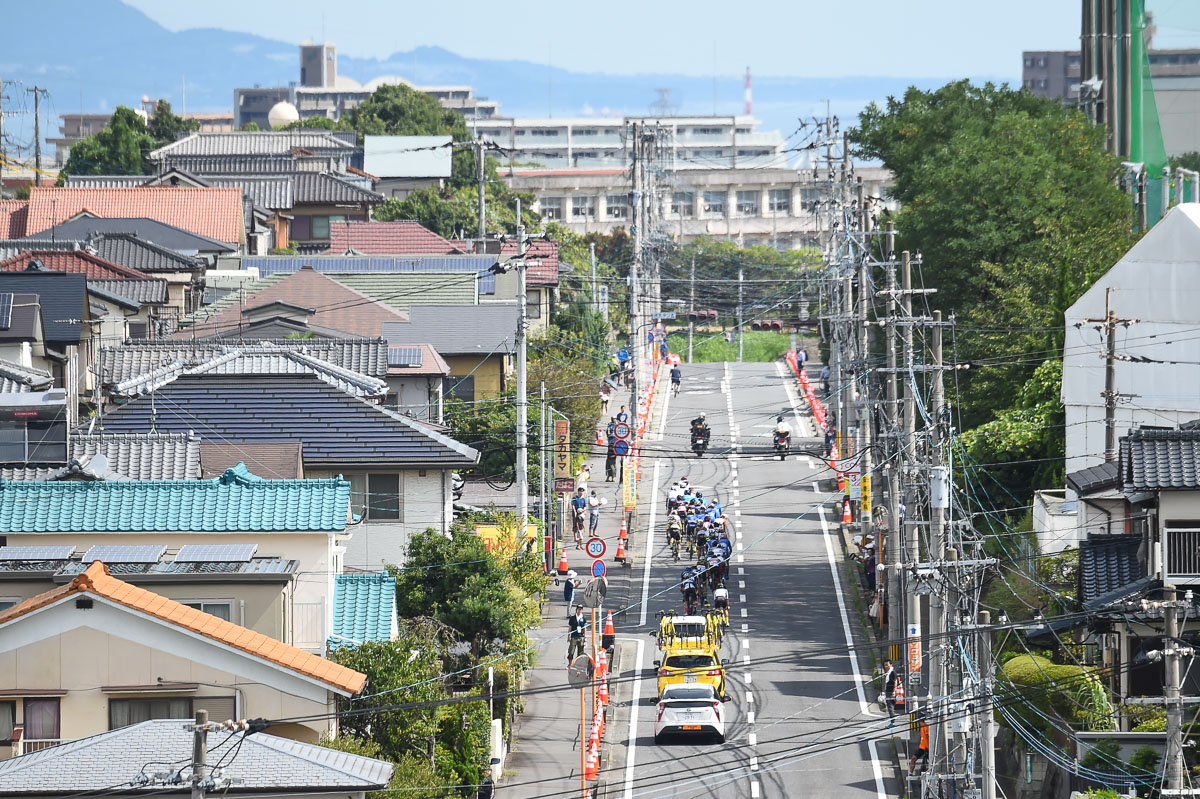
left=467, top=116, right=787, bottom=170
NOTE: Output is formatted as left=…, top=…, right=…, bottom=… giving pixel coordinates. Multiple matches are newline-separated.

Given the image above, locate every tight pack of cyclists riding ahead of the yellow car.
left=666, top=477, right=733, bottom=614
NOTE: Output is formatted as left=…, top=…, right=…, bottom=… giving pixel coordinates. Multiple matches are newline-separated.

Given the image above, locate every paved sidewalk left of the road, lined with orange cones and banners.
left=497, top=374, right=660, bottom=797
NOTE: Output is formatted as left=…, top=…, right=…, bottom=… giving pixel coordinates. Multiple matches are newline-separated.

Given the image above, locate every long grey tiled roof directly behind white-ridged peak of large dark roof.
left=100, top=338, right=388, bottom=385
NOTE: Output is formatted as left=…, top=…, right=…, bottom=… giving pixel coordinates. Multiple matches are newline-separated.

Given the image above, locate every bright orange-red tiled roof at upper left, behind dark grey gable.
left=25, top=186, right=245, bottom=244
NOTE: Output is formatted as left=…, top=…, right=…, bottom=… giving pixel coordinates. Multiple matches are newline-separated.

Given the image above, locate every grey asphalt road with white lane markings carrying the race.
left=606, top=364, right=898, bottom=799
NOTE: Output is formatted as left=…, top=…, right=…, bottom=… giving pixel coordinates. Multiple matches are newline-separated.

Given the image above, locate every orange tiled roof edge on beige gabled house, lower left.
left=0, top=560, right=367, bottom=693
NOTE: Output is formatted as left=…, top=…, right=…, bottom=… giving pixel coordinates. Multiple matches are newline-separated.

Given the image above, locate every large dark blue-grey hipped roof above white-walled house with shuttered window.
left=98, top=374, right=479, bottom=467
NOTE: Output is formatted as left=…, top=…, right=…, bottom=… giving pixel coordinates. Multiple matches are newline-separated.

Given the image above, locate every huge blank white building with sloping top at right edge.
left=1062, top=203, right=1200, bottom=474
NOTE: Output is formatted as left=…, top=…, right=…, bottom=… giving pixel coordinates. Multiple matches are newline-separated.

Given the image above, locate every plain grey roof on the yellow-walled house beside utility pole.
left=383, top=302, right=517, bottom=358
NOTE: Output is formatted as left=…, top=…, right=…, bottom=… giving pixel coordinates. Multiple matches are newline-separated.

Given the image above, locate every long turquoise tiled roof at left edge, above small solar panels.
left=0, top=463, right=350, bottom=533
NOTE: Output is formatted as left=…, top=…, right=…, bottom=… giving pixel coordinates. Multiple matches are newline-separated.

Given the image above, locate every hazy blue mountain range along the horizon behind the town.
left=0, top=0, right=1003, bottom=144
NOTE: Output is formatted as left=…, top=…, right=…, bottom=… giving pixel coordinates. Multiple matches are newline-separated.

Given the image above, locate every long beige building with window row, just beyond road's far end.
left=506, top=167, right=894, bottom=250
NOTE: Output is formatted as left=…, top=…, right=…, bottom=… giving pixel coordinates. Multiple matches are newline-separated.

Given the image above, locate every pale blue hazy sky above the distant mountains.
left=125, top=0, right=1089, bottom=79
